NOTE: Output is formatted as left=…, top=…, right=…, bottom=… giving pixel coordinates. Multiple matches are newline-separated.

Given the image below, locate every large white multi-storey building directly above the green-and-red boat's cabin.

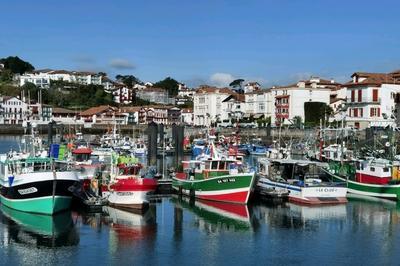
left=193, top=86, right=235, bottom=126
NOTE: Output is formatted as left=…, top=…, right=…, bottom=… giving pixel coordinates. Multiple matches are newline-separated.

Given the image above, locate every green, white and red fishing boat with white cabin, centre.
left=172, top=144, right=255, bottom=204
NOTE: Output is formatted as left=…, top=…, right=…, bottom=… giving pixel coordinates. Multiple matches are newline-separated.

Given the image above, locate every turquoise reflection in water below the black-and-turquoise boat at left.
left=1, top=205, right=79, bottom=248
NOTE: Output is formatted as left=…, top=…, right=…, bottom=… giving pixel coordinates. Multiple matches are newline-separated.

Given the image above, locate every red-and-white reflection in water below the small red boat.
left=103, top=206, right=157, bottom=246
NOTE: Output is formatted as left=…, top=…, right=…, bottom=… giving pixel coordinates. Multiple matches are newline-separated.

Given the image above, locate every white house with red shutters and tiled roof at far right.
left=344, top=72, right=400, bottom=129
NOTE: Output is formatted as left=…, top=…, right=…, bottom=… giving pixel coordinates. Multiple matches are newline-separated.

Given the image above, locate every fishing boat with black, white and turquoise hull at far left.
left=0, top=153, right=79, bottom=215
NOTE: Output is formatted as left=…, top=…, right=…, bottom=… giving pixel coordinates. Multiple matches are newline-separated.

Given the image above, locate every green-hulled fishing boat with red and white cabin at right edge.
left=324, top=158, right=400, bottom=201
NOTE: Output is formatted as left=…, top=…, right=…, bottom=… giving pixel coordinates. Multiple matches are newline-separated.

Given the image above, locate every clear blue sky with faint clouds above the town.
left=0, top=0, right=400, bottom=87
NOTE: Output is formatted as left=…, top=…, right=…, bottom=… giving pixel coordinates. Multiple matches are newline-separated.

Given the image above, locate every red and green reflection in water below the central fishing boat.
left=172, top=196, right=251, bottom=232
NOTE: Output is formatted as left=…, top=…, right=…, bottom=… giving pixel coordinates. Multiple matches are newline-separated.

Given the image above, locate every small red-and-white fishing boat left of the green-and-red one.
left=102, top=156, right=157, bottom=210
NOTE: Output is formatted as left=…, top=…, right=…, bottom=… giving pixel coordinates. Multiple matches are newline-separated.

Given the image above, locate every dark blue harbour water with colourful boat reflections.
left=0, top=137, right=400, bottom=265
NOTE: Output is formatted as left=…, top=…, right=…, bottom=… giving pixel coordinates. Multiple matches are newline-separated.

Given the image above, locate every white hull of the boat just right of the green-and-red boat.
left=257, top=177, right=347, bottom=204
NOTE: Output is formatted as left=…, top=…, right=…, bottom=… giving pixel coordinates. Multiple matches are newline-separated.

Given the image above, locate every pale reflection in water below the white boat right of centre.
left=254, top=202, right=347, bottom=229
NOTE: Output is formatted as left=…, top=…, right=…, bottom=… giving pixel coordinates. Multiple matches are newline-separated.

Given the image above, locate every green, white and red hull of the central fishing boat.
left=172, top=173, right=254, bottom=204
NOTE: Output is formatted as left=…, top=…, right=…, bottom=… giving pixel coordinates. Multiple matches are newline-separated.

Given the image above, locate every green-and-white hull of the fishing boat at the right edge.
left=324, top=169, right=400, bottom=200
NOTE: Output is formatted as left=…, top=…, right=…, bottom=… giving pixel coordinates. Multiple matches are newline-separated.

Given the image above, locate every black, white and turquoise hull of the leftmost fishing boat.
left=1, top=172, right=78, bottom=215
